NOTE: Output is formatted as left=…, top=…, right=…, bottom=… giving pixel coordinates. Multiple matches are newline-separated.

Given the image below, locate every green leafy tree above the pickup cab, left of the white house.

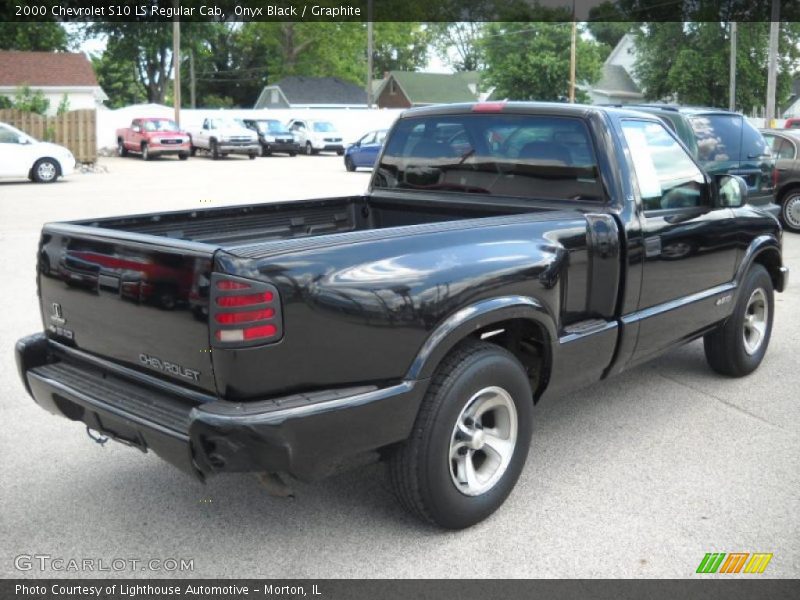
left=481, top=22, right=602, bottom=101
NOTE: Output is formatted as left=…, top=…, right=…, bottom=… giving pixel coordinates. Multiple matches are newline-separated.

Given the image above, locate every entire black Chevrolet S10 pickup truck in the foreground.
left=17, top=103, right=788, bottom=528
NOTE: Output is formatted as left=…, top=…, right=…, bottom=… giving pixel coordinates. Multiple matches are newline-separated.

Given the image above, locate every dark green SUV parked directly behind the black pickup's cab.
left=625, top=104, right=780, bottom=216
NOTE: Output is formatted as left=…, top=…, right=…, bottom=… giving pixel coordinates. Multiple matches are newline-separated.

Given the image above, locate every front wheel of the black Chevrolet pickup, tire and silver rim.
left=703, top=263, right=775, bottom=377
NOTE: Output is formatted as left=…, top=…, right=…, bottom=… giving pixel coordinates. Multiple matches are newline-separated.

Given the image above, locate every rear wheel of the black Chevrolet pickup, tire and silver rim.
left=389, top=341, right=533, bottom=529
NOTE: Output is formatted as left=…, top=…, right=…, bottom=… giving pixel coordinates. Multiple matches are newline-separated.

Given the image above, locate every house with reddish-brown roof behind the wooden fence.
left=0, top=51, right=108, bottom=115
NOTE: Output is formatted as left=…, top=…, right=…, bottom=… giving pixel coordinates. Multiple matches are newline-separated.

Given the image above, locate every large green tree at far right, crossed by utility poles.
left=635, top=22, right=800, bottom=112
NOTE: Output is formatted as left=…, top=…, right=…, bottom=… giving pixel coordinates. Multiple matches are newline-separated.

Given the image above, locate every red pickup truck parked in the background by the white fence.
left=117, top=117, right=191, bottom=160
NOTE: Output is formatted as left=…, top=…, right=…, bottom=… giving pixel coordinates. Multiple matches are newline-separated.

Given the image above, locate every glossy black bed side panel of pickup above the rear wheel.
left=212, top=212, right=587, bottom=399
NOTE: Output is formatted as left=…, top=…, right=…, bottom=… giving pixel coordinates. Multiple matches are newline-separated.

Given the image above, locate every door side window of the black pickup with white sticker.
left=622, top=120, right=707, bottom=210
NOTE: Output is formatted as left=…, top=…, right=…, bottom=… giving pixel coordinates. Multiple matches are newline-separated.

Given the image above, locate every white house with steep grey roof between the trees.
left=581, top=33, right=644, bottom=104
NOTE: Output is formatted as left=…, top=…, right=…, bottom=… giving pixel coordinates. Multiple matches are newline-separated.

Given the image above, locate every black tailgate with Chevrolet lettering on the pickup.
left=38, top=225, right=215, bottom=393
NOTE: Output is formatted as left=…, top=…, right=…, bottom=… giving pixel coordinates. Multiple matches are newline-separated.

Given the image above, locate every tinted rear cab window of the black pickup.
left=373, top=114, right=605, bottom=202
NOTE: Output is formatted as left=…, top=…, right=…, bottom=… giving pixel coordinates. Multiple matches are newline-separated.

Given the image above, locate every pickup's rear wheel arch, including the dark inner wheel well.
left=406, top=296, right=557, bottom=398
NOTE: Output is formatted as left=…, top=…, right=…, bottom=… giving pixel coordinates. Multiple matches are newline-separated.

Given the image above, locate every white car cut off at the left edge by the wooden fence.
left=0, top=123, right=75, bottom=183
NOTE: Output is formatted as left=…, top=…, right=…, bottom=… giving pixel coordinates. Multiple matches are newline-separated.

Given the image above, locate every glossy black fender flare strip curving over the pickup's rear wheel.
left=405, top=296, right=558, bottom=380
